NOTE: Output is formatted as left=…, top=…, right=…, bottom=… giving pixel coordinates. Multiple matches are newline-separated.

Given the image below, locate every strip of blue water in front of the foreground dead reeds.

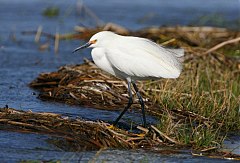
left=0, top=131, right=234, bottom=163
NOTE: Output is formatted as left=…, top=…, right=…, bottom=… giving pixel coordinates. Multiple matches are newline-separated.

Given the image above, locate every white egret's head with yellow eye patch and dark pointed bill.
left=73, top=31, right=117, bottom=53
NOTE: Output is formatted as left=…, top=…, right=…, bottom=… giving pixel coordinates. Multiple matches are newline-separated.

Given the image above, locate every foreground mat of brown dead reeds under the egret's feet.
left=0, top=108, right=179, bottom=151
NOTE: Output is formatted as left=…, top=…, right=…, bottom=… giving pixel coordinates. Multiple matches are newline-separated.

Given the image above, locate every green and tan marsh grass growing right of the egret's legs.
left=145, top=55, right=240, bottom=148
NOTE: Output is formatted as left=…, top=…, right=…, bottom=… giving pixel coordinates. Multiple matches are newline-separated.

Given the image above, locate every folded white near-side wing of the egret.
left=106, top=47, right=181, bottom=78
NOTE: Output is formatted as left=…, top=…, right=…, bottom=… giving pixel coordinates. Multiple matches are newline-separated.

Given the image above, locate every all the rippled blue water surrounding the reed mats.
left=0, top=0, right=240, bottom=162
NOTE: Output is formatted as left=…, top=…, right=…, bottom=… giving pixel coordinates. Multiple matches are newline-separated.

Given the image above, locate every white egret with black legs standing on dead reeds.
left=73, top=31, right=184, bottom=127
